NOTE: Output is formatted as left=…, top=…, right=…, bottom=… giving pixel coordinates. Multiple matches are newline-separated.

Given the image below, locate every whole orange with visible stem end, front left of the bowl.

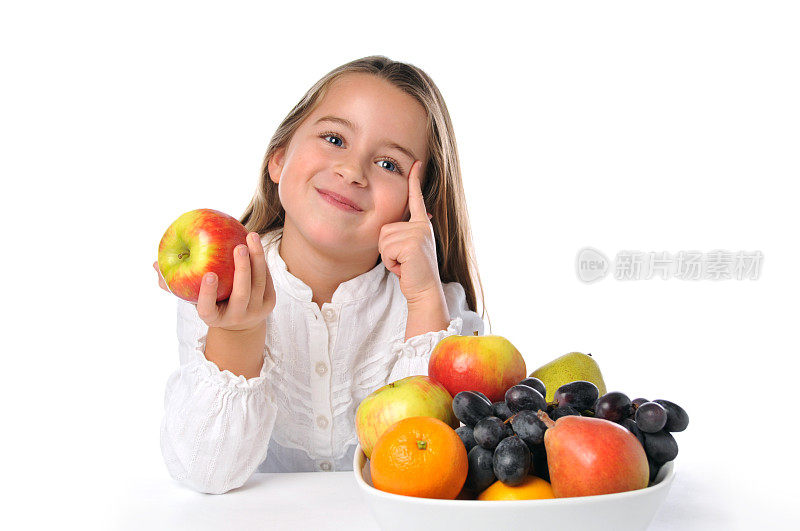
left=369, top=417, right=468, bottom=500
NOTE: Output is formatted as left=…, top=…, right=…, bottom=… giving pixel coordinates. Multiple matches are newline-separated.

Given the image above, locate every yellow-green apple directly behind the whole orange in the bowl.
left=356, top=375, right=460, bottom=458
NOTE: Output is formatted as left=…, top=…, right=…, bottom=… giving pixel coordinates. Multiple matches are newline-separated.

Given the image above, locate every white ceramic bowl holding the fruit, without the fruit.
left=353, top=446, right=675, bottom=531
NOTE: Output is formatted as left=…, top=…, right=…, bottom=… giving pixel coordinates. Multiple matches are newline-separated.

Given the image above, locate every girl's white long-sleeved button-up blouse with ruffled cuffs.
left=161, top=229, right=483, bottom=494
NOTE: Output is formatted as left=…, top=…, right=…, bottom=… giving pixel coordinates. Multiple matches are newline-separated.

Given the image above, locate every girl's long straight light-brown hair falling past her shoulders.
left=240, top=55, right=491, bottom=327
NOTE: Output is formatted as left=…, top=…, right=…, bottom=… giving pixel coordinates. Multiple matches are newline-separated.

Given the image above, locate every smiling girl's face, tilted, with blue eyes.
left=268, top=73, right=428, bottom=259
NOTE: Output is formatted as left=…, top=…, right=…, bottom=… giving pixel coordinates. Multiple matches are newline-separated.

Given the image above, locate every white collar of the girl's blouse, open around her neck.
left=261, top=228, right=389, bottom=304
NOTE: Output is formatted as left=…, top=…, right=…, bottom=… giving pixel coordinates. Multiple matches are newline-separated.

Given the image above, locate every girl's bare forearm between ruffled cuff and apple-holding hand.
left=206, top=321, right=267, bottom=378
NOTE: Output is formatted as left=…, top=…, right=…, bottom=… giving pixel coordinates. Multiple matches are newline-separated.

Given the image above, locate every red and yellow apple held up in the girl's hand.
left=158, top=208, right=247, bottom=303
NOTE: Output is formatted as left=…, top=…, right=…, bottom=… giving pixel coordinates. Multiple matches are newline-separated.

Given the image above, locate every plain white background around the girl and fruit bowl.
left=0, top=1, right=800, bottom=529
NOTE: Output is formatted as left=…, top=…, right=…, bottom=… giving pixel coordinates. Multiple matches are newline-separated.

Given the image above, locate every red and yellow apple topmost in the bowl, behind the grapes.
left=428, top=336, right=527, bottom=402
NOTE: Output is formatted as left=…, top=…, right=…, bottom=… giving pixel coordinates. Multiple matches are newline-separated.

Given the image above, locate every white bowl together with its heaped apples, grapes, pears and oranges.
left=353, top=337, right=688, bottom=531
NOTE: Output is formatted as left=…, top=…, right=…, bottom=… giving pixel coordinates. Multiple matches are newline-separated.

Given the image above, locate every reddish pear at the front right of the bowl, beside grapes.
left=538, top=411, right=650, bottom=498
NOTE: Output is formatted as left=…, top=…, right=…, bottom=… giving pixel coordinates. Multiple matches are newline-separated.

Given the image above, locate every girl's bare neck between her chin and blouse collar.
left=278, top=220, right=378, bottom=308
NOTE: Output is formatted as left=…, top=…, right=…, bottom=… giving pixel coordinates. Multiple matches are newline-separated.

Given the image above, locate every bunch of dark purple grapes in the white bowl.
left=453, top=377, right=689, bottom=492
